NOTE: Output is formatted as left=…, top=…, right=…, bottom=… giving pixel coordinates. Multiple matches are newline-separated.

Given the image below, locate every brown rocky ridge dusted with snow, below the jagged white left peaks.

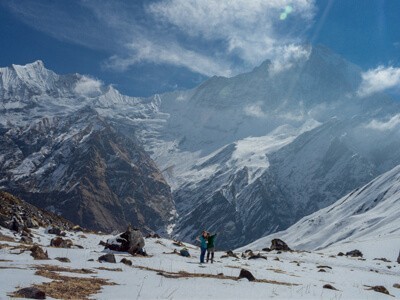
left=0, top=108, right=174, bottom=232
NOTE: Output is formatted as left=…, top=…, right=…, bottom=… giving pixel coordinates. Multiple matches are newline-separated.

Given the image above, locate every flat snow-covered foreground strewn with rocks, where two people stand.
left=0, top=227, right=400, bottom=299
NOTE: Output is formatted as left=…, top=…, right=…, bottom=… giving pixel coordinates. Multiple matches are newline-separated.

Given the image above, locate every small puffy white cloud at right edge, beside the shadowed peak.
left=357, top=66, right=400, bottom=97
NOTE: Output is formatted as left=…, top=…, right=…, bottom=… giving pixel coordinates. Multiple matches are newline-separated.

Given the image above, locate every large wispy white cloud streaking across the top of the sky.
left=3, top=0, right=316, bottom=76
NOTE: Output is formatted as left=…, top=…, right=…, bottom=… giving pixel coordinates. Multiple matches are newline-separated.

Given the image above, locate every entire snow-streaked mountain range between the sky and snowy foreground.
left=0, top=47, right=400, bottom=249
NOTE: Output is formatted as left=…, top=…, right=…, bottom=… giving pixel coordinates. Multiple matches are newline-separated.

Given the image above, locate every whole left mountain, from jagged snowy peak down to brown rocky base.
left=0, top=62, right=175, bottom=232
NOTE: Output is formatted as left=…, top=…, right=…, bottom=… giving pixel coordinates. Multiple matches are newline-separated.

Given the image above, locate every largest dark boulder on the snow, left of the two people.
left=105, top=226, right=147, bottom=255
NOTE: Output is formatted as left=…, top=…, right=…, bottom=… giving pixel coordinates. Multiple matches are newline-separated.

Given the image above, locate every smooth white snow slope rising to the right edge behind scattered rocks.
left=245, top=165, right=400, bottom=257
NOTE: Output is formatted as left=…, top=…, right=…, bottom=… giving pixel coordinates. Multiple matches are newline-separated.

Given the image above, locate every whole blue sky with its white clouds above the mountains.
left=0, top=0, right=400, bottom=96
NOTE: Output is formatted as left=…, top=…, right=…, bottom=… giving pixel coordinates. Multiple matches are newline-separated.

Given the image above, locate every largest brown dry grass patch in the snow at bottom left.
left=34, top=266, right=116, bottom=299
